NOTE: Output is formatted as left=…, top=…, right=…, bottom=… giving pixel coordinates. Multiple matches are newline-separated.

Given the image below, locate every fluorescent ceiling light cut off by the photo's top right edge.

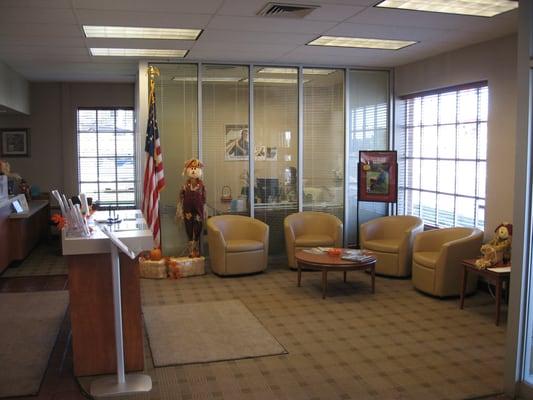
left=376, top=0, right=518, bottom=17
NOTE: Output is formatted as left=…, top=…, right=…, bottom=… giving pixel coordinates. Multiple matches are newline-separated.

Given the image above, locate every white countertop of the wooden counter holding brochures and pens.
left=61, top=210, right=154, bottom=255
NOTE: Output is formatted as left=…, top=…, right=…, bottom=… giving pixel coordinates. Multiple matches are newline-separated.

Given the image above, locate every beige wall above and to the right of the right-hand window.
left=395, top=35, right=517, bottom=237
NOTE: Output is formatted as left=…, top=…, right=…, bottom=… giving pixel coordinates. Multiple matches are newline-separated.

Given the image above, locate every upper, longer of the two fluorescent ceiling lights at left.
left=83, top=25, right=202, bottom=40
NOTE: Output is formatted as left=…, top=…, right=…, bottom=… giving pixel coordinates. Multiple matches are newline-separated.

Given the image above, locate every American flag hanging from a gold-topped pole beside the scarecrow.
left=142, top=80, right=165, bottom=247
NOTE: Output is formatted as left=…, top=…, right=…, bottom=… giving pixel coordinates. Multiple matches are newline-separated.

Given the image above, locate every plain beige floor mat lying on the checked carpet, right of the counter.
left=143, top=300, right=286, bottom=367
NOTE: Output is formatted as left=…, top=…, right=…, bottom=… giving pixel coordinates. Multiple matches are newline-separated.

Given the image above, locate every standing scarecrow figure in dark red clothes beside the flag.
left=176, top=158, right=205, bottom=258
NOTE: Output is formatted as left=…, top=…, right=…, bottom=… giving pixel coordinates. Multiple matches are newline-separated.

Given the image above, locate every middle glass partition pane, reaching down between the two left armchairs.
left=253, top=67, right=298, bottom=255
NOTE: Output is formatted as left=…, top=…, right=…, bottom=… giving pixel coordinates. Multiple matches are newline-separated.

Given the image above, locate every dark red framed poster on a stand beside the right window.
left=358, top=150, right=398, bottom=203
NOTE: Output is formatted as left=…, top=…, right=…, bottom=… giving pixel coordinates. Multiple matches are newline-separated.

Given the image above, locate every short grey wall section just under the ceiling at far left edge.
left=0, top=61, right=30, bottom=114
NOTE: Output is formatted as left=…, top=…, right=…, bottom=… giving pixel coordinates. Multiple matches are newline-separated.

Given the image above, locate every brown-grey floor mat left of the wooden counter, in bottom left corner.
left=0, top=291, right=68, bottom=397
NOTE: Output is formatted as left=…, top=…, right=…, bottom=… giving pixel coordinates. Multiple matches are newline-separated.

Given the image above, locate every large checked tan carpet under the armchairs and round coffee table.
left=81, top=266, right=506, bottom=400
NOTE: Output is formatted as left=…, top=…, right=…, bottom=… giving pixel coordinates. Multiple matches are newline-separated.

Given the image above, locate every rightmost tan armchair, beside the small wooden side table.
left=413, top=228, right=483, bottom=297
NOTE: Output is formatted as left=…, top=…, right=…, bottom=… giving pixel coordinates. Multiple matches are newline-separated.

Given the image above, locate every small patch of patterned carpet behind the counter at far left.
left=0, top=239, right=68, bottom=278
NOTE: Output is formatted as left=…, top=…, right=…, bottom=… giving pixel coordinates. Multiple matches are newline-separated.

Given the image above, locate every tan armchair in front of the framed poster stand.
left=359, top=215, right=424, bottom=277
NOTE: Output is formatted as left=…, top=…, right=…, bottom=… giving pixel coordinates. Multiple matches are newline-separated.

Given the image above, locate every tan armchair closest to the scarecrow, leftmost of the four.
left=207, top=215, right=268, bottom=275
